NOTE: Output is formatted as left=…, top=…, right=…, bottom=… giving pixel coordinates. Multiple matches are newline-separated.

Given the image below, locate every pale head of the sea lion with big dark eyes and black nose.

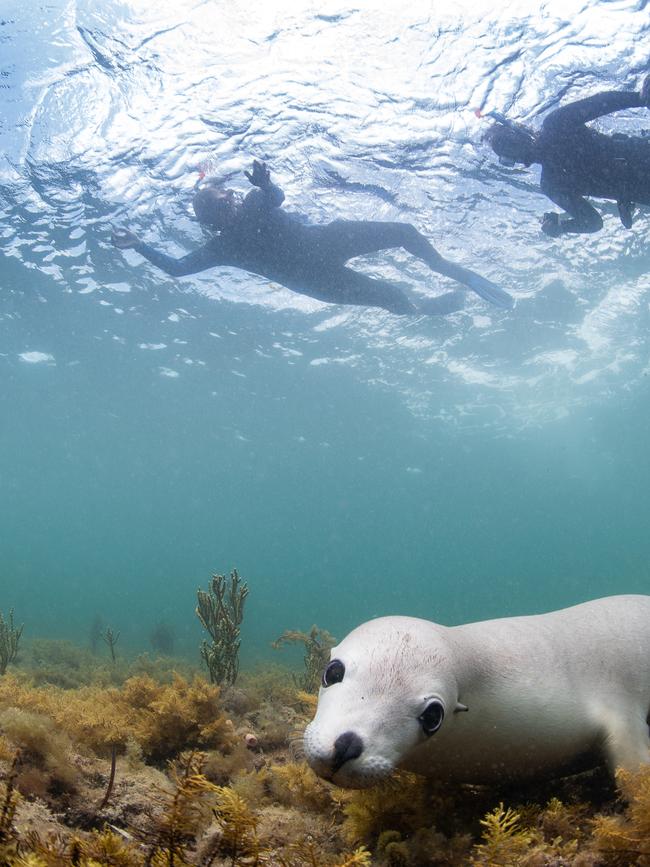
left=304, top=617, right=463, bottom=789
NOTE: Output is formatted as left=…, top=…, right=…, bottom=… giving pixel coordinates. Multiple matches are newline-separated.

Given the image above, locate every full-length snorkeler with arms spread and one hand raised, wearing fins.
left=112, top=160, right=513, bottom=315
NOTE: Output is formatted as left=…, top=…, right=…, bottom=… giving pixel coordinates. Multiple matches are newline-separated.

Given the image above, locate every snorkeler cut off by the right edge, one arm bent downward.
left=485, top=75, right=650, bottom=238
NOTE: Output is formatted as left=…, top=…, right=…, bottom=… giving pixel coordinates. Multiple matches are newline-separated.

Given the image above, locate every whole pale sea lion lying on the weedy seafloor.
left=304, top=596, right=650, bottom=788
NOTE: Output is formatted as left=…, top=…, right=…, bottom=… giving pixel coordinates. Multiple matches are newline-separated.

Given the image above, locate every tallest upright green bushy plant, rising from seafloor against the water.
left=196, top=569, right=248, bottom=684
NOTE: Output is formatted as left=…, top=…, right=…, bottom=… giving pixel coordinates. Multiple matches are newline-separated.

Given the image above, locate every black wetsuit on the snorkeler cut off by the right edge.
left=536, top=91, right=650, bottom=233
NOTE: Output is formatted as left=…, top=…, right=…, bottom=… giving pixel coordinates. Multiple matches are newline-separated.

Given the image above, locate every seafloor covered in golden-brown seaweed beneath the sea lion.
left=0, top=640, right=650, bottom=867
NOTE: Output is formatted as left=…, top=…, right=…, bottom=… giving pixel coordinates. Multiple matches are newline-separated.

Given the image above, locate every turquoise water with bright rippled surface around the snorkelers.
left=0, top=0, right=650, bottom=661
